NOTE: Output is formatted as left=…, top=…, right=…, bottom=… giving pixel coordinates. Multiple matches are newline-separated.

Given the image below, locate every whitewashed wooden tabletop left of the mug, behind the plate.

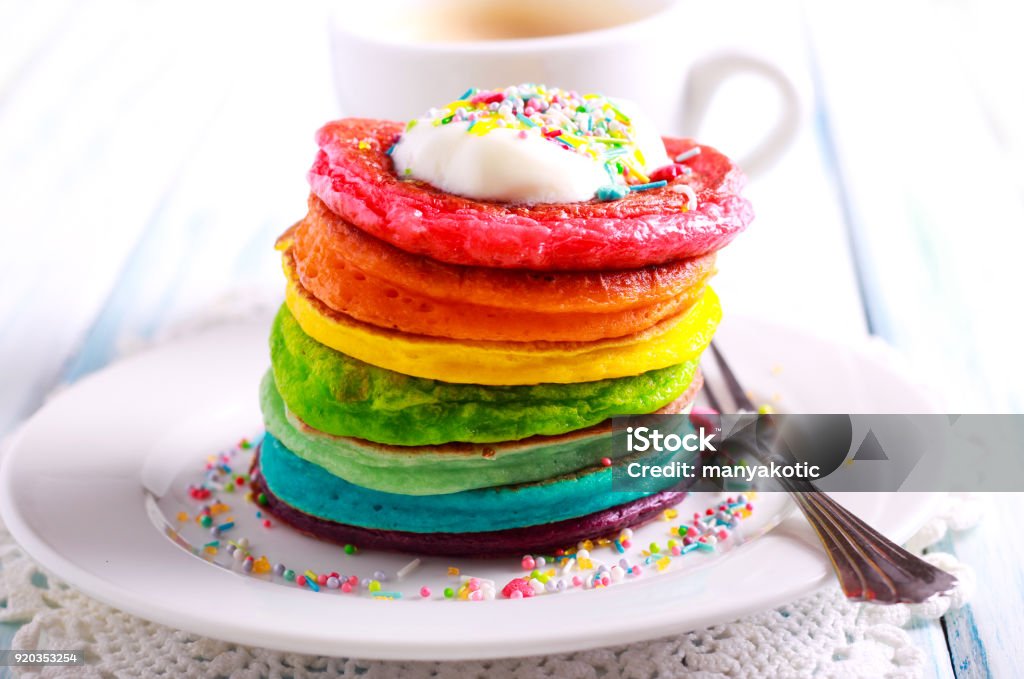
left=0, top=2, right=333, bottom=431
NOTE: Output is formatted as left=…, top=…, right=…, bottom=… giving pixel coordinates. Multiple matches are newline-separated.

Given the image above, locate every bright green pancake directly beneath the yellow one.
left=270, top=306, right=697, bottom=445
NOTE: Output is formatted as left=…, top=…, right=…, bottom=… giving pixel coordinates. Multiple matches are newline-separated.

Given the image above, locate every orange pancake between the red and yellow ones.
left=282, top=198, right=715, bottom=342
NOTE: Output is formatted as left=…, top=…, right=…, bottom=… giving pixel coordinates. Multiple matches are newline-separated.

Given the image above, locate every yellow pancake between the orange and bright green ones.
left=285, top=261, right=722, bottom=385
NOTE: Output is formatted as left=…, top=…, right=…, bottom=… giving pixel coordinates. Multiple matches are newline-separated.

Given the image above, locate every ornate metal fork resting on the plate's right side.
left=703, top=342, right=956, bottom=603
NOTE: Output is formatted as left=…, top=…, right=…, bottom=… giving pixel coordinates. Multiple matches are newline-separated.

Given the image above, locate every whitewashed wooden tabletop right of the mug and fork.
left=805, top=1, right=1024, bottom=678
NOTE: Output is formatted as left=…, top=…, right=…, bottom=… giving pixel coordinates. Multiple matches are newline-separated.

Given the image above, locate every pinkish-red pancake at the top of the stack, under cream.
left=308, top=118, right=754, bottom=270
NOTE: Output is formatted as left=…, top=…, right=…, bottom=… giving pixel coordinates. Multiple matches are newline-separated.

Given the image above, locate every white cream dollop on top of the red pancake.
left=391, top=100, right=671, bottom=204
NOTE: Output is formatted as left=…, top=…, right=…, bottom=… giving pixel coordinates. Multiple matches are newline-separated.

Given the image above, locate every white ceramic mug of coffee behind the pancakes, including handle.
left=331, top=0, right=801, bottom=174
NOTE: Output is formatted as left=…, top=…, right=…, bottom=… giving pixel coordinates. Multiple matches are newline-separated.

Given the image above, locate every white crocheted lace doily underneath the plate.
left=0, top=305, right=984, bottom=679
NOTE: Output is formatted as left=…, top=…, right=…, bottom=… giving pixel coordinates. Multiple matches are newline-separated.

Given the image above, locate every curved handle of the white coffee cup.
left=683, top=52, right=801, bottom=176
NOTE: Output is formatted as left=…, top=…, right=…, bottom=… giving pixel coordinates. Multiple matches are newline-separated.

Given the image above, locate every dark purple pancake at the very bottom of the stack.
left=250, top=462, right=686, bottom=558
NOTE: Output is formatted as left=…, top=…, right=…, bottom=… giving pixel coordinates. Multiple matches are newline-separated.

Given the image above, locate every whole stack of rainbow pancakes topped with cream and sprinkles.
left=252, top=84, right=752, bottom=556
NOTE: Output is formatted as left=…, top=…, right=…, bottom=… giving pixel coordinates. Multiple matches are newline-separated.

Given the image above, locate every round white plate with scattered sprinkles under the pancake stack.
left=0, top=319, right=936, bottom=660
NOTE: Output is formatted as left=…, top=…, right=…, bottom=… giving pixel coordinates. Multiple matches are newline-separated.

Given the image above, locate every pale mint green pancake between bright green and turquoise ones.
left=260, top=373, right=701, bottom=495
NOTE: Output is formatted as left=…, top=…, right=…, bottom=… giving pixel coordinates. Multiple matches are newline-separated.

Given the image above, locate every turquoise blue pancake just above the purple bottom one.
left=259, top=433, right=692, bottom=534
